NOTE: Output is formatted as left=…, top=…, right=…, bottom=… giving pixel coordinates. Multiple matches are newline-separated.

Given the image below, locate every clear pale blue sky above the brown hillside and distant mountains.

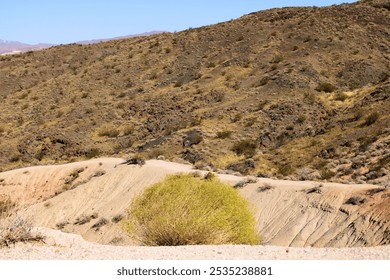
left=0, top=0, right=355, bottom=44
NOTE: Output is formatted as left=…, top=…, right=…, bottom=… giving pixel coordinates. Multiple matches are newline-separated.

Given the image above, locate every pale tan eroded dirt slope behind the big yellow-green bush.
left=0, top=159, right=390, bottom=247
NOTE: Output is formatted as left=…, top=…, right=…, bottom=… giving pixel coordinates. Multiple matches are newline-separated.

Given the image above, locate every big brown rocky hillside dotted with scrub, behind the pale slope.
left=0, top=0, right=390, bottom=186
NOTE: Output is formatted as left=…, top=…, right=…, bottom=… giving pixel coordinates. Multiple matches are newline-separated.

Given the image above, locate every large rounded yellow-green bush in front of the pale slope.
left=127, top=174, right=259, bottom=246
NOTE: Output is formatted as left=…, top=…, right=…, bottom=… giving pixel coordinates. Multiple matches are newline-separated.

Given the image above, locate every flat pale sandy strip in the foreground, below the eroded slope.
left=0, top=228, right=390, bottom=260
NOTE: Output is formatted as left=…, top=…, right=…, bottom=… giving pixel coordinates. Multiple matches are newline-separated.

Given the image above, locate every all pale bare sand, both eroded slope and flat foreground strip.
left=0, top=159, right=390, bottom=259
